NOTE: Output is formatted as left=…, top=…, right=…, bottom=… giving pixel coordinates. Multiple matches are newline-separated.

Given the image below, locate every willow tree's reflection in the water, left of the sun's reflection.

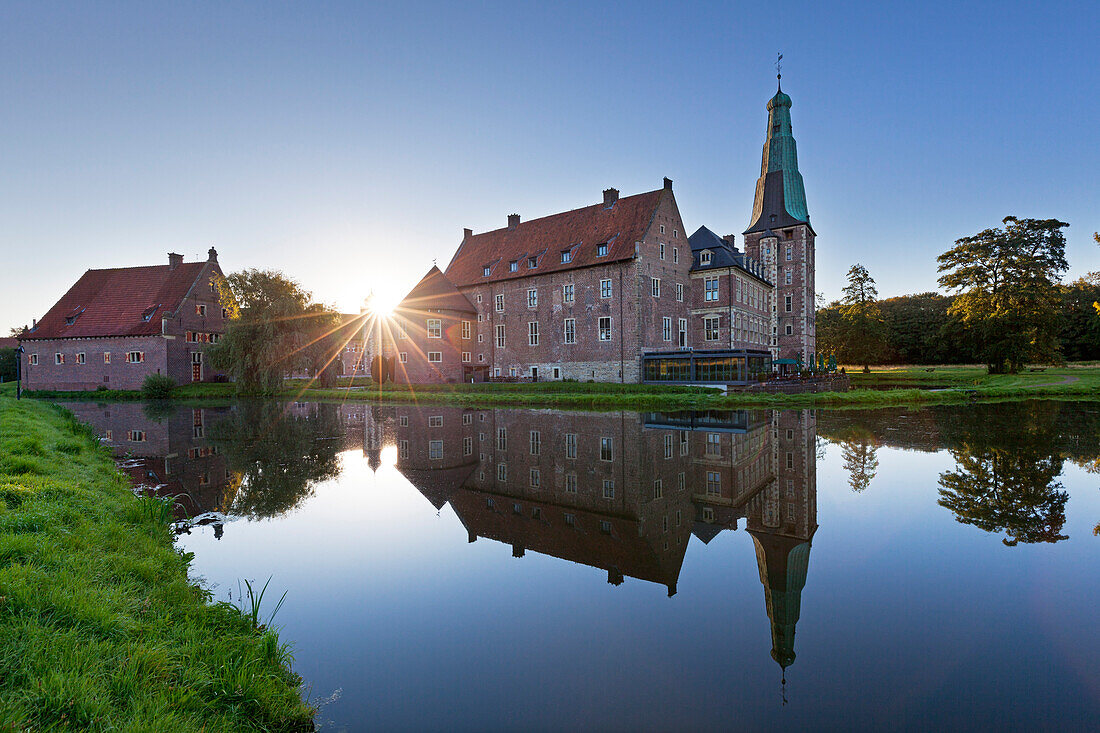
left=210, top=402, right=343, bottom=518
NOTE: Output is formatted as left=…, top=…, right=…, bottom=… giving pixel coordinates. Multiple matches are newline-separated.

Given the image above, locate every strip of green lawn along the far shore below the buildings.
left=17, top=364, right=1100, bottom=411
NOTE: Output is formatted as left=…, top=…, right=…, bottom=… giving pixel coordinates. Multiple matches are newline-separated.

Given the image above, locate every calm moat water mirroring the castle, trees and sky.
left=67, top=402, right=1100, bottom=731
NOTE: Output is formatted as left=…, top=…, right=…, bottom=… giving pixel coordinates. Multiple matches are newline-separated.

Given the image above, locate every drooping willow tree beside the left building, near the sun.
left=210, top=270, right=339, bottom=395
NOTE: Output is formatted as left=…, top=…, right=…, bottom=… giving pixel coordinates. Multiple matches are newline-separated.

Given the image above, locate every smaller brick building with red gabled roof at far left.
left=19, top=248, right=228, bottom=390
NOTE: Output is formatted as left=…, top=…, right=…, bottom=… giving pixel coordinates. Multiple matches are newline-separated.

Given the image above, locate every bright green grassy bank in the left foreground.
left=0, top=389, right=311, bottom=731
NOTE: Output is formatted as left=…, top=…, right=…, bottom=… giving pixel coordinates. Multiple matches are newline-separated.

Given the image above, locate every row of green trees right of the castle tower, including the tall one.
left=817, top=217, right=1100, bottom=365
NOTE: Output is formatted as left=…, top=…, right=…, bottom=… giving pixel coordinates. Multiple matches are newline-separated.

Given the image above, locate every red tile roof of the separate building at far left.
left=22, top=262, right=213, bottom=339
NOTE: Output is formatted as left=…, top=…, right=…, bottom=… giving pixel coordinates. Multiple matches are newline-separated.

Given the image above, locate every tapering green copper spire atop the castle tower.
left=746, top=75, right=810, bottom=233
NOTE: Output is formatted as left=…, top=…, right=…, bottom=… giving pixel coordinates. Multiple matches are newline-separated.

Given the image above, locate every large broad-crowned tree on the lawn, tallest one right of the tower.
left=938, top=217, right=1069, bottom=367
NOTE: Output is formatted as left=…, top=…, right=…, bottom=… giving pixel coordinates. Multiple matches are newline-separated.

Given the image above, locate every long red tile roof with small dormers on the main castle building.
left=447, top=188, right=666, bottom=287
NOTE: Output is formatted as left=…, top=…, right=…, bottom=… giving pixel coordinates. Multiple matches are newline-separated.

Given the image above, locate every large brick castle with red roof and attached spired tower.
left=382, top=80, right=815, bottom=383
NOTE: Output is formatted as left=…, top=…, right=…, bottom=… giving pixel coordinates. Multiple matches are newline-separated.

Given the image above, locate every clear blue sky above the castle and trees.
left=0, top=0, right=1100, bottom=323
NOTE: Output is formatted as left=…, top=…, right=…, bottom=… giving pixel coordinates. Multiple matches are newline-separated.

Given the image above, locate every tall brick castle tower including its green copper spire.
left=744, top=72, right=816, bottom=362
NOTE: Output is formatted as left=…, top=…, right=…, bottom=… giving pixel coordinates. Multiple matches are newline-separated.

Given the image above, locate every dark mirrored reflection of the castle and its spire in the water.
left=378, top=406, right=817, bottom=669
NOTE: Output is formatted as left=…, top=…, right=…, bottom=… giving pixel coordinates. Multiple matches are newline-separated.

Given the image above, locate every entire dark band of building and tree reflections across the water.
left=67, top=402, right=1100, bottom=695
